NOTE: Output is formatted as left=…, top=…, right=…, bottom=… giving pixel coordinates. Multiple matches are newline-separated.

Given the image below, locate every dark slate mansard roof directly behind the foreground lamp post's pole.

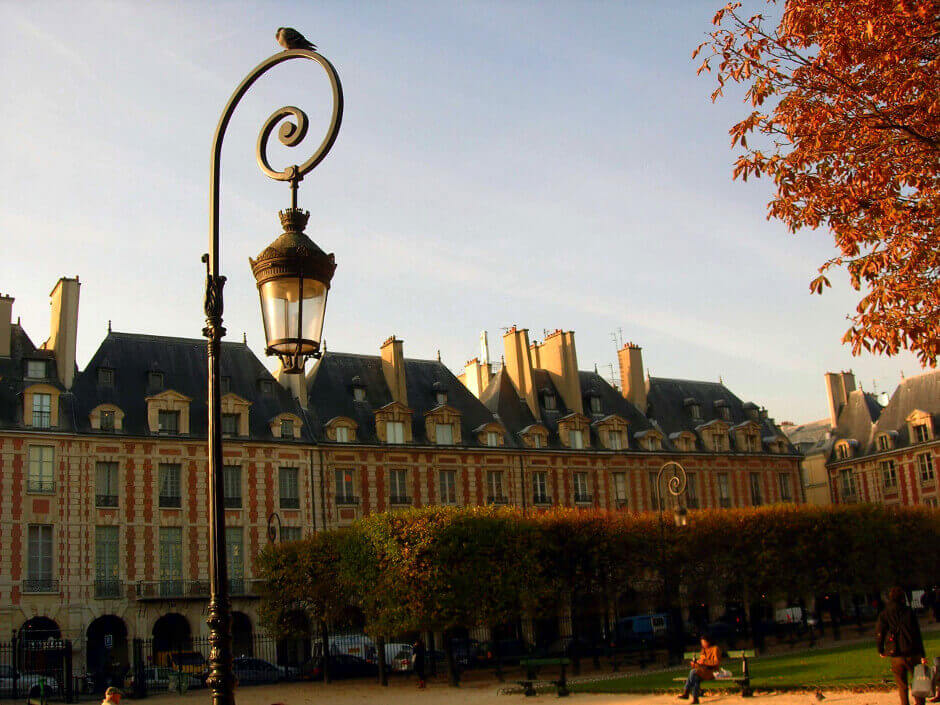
left=63, top=333, right=309, bottom=440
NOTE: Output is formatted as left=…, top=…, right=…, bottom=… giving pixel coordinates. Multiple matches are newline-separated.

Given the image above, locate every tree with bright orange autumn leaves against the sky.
left=693, top=0, right=940, bottom=366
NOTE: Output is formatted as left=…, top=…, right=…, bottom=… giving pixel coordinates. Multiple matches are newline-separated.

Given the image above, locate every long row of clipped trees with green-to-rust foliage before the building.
left=259, top=505, right=940, bottom=648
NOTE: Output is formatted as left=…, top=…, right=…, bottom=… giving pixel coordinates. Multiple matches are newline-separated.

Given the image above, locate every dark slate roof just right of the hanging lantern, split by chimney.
left=307, top=352, right=500, bottom=447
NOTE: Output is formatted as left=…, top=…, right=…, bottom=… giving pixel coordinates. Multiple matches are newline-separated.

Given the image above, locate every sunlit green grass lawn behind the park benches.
left=571, top=632, right=940, bottom=693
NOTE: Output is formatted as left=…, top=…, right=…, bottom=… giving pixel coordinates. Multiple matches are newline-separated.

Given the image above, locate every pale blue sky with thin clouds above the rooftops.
left=0, top=0, right=922, bottom=423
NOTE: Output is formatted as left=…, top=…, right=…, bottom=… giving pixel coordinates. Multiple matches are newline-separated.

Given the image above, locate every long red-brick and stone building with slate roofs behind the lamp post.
left=0, top=278, right=803, bottom=669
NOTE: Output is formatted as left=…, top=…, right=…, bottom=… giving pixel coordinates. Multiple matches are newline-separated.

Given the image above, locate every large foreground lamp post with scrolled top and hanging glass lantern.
left=202, top=34, right=343, bottom=705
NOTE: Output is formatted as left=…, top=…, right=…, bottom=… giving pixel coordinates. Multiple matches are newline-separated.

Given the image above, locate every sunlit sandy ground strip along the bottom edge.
left=140, top=681, right=912, bottom=705
